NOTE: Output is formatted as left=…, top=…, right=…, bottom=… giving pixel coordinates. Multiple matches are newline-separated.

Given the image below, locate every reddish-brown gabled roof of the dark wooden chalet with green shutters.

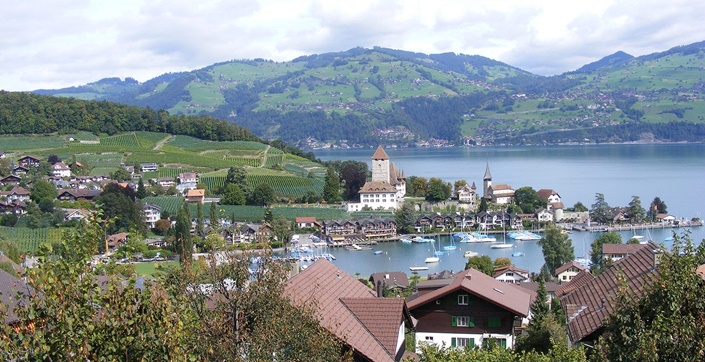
left=408, top=268, right=532, bottom=317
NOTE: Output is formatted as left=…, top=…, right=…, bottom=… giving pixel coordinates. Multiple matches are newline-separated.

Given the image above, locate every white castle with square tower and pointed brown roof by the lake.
left=347, top=146, right=406, bottom=212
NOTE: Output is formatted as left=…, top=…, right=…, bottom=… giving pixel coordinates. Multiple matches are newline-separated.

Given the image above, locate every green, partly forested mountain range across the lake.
left=37, top=42, right=705, bottom=148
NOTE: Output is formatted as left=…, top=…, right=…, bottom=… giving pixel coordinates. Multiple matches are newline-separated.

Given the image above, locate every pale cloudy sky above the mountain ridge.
left=0, top=0, right=705, bottom=91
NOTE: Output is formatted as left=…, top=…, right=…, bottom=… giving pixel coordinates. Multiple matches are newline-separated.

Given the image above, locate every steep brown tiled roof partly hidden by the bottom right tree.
left=561, top=243, right=660, bottom=343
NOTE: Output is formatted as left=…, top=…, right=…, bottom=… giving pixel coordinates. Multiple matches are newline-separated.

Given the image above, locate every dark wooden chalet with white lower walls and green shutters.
left=407, top=269, right=533, bottom=349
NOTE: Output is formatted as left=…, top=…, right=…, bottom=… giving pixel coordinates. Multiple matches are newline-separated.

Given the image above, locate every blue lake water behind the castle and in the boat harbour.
left=315, top=144, right=705, bottom=275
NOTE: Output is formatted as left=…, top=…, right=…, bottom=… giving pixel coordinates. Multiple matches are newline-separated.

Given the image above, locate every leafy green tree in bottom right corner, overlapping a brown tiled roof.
left=596, top=235, right=705, bottom=361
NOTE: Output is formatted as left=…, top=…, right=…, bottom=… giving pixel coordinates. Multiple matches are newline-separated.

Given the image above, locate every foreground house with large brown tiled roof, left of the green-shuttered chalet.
left=284, top=259, right=413, bottom=361
